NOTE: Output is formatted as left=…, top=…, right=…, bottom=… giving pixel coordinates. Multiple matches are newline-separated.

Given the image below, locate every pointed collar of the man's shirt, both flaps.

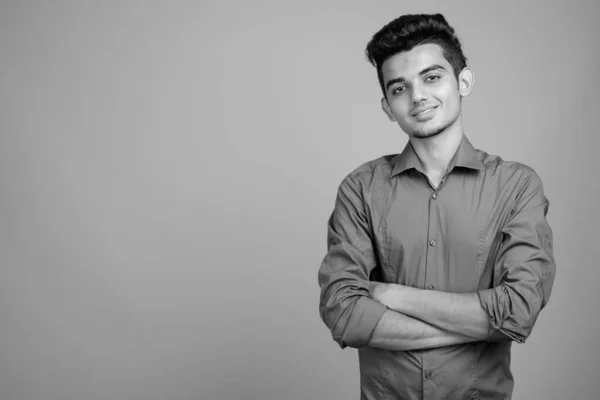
left=392, top=135, right=485, bottom=176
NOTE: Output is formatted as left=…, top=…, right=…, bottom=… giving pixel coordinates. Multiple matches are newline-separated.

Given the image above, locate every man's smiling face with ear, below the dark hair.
left=381, top=43, right=472, bottom=138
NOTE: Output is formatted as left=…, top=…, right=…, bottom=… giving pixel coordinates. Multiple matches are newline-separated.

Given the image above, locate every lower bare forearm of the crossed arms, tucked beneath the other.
left=368, top=310, right=477, bottom=351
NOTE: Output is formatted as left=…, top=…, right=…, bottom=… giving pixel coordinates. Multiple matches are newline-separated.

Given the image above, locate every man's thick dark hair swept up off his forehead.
left=365, top=14, right=467, bottom=97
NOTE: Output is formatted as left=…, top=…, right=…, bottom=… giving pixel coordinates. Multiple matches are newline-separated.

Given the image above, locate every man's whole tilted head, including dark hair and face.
left=366, top=14, right=473, bottom=138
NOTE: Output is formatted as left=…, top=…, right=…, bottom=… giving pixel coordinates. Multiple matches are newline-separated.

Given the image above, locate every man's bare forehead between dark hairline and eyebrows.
left=381, top=43, right=452, bottom=83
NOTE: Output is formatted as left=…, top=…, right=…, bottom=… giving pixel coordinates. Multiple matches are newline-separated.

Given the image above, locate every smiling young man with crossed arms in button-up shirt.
left=319, top=14, right=555, bottom=399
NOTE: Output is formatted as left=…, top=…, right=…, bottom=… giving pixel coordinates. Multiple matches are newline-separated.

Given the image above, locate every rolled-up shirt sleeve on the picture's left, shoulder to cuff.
left=318, top=176, right=386, bottom=348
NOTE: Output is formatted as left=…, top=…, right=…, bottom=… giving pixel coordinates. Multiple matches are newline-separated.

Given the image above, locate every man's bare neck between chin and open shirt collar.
left=410, top=119, right=463, bottom=175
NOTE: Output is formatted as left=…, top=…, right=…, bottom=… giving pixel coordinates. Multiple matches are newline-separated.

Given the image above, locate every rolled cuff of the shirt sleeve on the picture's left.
left=341, top=296, right=387, bottom=348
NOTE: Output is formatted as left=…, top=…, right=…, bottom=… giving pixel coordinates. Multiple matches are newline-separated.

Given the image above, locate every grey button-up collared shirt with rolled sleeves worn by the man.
left=319, top=136, right=556, bottom=400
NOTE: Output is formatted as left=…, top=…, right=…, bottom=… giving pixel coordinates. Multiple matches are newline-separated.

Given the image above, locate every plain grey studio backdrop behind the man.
left=0, top=0, right=600, bottom=400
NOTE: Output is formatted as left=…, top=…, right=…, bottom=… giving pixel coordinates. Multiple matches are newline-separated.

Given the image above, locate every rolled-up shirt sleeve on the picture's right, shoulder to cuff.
left=477, top=171, right=556, bottom=343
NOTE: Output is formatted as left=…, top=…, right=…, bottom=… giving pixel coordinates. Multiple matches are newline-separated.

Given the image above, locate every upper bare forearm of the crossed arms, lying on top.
left=376, top=284, right=490, bottom=340
